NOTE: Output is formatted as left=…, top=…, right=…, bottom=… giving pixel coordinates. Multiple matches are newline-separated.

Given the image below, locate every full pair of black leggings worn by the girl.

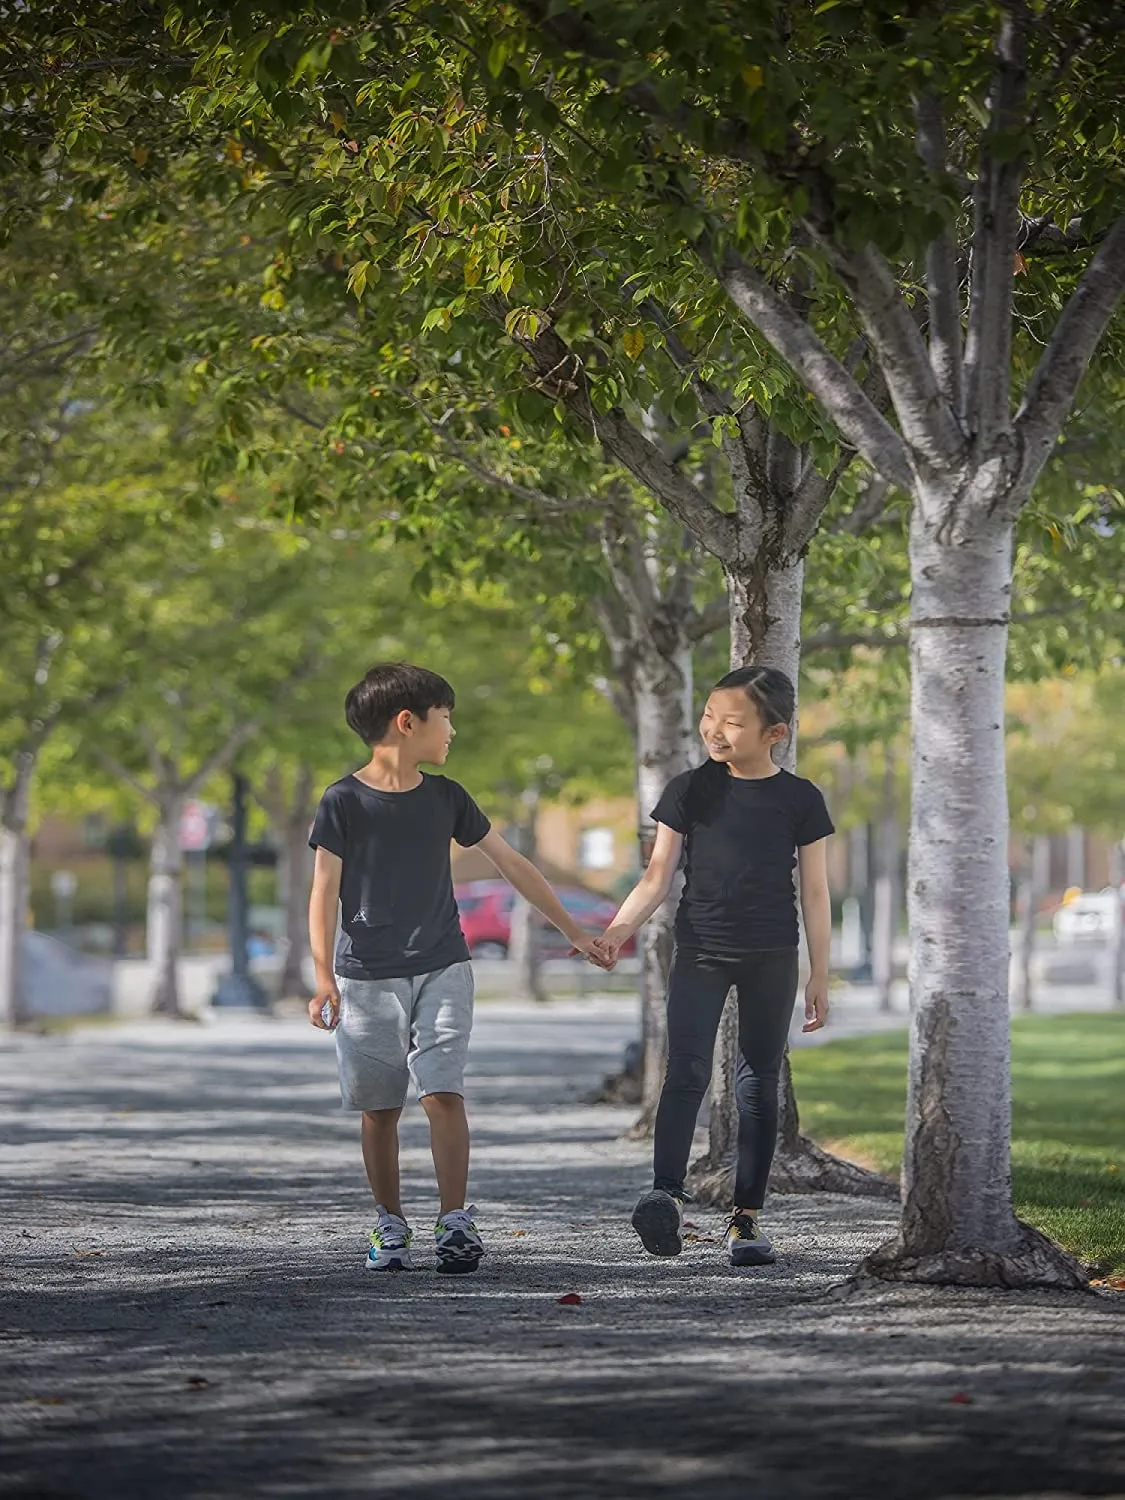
left=653, top=948, right=797, bottom=1209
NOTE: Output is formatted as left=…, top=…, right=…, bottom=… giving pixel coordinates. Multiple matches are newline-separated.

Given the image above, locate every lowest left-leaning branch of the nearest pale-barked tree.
left=717, top=254, right=914, bottom=492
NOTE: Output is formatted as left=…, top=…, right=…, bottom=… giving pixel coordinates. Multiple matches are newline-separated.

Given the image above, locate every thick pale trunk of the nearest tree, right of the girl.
left=867, top=516, right=1083, bottom=1286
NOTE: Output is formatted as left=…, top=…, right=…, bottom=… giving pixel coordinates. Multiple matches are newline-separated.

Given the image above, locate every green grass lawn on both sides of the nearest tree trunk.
left=792, top=1014, right=1125, bottom=1272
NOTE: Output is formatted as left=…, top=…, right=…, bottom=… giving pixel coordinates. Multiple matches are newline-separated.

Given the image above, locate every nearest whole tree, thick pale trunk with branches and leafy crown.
left=468, top=0, right=1125, bottom=1286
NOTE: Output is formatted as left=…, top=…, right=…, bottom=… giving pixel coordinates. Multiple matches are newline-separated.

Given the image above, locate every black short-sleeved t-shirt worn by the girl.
left=653, top=761, right=836, bottom=957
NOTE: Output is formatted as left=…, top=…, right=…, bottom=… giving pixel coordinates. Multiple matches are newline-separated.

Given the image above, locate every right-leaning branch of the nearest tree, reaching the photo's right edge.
left=1016, top=215, right=1125, bottom=509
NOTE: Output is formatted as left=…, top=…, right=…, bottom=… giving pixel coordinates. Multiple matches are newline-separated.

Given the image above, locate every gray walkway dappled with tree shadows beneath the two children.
left=0, top=1001, right=1125, bottom=1500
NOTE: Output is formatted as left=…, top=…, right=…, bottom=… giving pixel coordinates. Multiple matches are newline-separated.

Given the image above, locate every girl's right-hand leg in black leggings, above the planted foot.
left=735, top=948, right=798, bottom=1212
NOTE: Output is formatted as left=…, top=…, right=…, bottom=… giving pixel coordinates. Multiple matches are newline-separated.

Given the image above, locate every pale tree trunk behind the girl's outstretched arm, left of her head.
left=630, top=639, right=695, bottom=1139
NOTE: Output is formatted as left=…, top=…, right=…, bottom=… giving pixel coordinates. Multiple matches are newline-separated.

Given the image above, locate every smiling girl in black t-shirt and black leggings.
left=597, top=666, right=834, bottom=1266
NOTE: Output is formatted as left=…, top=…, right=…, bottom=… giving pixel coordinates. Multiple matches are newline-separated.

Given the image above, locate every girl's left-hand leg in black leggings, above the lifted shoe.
left=653, top=953, right=734, bottom=1197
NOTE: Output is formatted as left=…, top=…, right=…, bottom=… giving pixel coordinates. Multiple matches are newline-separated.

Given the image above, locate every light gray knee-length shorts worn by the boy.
left=336, top=962, right=473, bottom=1110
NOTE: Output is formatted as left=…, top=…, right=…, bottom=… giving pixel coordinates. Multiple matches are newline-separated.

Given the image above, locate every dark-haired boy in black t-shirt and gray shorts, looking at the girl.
left=309, top=663, right=612, bottom=1274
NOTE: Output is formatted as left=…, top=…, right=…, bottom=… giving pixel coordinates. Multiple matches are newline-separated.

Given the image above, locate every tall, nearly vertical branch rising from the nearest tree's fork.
left=962, top=6, right=1029, bottom=447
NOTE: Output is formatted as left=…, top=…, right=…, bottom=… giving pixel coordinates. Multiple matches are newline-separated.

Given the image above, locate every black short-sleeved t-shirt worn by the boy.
left=309, top=773, right=491, bottom=980
